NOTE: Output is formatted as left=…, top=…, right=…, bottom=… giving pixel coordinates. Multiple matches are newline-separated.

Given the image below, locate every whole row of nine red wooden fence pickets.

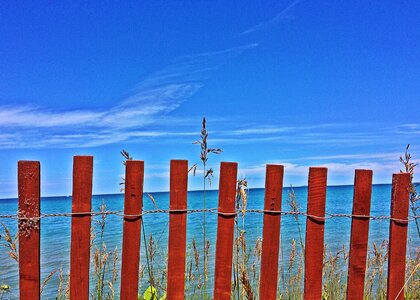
left=11, top=156, right=410, bottom=300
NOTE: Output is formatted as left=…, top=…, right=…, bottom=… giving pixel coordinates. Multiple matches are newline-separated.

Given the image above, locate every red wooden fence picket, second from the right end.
left=347, top=170, right=372, bottom=300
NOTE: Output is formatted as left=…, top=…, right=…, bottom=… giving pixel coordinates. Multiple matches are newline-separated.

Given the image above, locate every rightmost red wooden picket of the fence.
left=387, top=173, right=411, bottom=300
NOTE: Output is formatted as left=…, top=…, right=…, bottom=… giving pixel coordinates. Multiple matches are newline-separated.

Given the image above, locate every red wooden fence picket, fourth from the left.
left=167, top=160, right=188, bottom=299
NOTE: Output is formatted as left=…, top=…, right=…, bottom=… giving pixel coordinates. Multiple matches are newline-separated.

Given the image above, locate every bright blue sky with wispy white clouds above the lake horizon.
left=0, top=1, right=420, bottom=197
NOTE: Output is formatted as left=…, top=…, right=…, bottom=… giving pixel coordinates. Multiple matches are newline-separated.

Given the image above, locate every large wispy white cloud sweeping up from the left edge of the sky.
left=0, top=44, right=257, bottom=148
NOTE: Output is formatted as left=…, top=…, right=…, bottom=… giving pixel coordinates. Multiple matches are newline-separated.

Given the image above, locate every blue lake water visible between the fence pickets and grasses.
left=0, top=185, right=420, bottom=299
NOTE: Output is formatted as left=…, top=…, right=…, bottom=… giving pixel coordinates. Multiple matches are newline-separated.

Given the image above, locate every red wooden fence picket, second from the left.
left=70, top=156, right=93, bottom=300
